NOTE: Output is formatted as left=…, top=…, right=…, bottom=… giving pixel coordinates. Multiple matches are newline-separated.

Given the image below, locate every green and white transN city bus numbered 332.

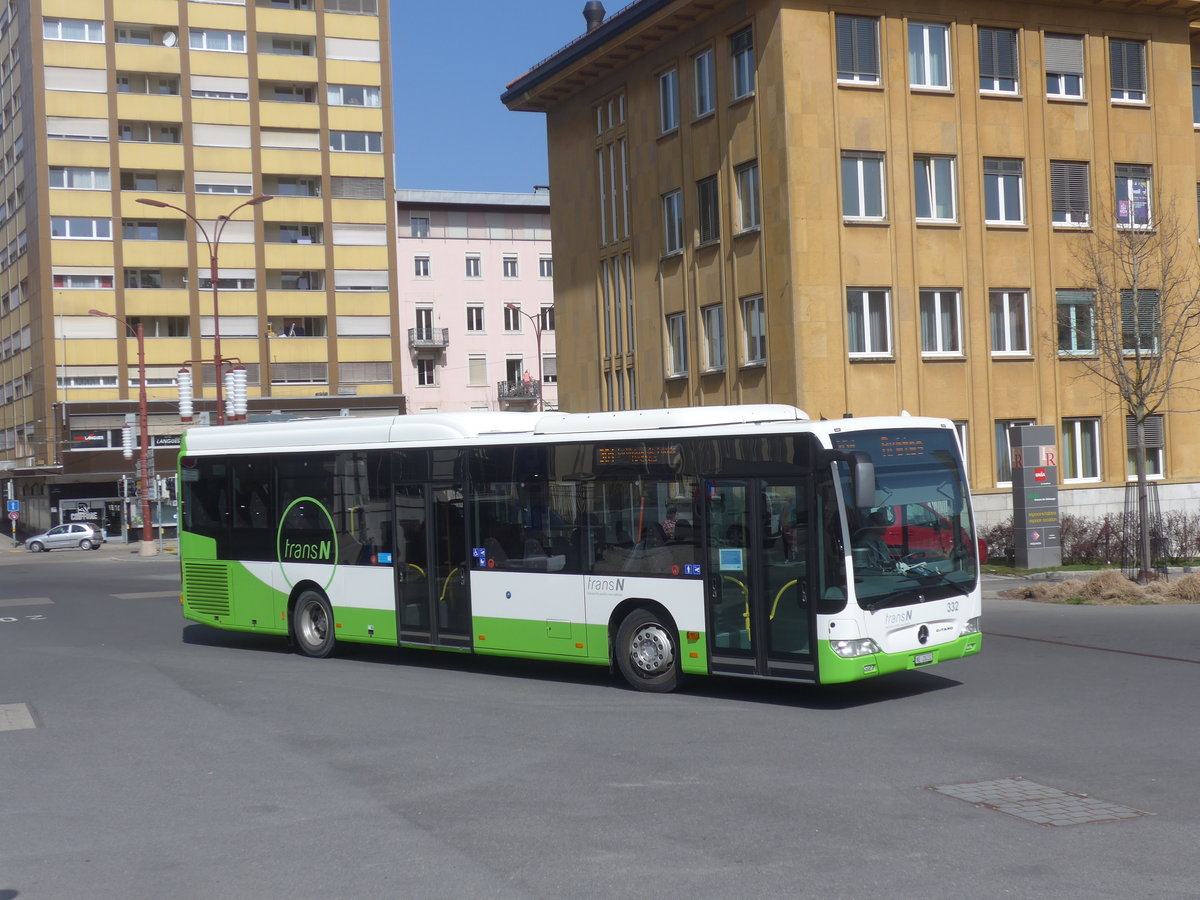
left=179, top=404, right=982, bottom=691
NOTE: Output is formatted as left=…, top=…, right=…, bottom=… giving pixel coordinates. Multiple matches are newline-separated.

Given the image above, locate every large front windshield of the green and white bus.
left=834, top=430, right=979, bottom=610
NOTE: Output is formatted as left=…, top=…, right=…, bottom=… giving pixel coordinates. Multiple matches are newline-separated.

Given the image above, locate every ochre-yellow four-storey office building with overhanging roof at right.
left=503, top=0, right=1200, bottom=518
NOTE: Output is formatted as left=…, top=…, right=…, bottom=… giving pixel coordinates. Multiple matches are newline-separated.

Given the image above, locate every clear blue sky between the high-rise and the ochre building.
left=391, top=0, right=588, bottom=192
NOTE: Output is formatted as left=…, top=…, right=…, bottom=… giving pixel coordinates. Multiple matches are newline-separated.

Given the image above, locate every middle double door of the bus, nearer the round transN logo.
left=395, top=485, right=470, bottom=647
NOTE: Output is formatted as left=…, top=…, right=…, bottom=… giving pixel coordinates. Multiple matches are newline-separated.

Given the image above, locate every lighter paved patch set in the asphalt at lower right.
left=928, top=775, right=1154, bottom=826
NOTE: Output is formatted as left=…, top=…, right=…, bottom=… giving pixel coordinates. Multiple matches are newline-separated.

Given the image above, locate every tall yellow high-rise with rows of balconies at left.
left=0, top=0, right=403, bottom=534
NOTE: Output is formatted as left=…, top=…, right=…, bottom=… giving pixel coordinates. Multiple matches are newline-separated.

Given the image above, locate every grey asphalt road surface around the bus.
left=0, top=547, right=1200, bottom=900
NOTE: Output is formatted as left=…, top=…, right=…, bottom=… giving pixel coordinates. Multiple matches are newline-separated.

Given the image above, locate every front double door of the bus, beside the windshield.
left=706, top=478, right=816, bottom=682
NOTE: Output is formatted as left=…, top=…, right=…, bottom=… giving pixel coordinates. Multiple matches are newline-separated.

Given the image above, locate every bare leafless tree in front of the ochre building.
left=1057, top=190, right=1200, bottom=581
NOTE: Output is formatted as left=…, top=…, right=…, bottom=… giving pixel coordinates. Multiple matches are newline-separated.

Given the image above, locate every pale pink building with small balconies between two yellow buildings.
left=396, top=191, right=558, bottom=413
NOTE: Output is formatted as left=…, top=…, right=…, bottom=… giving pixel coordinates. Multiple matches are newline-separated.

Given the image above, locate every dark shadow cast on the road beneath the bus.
left=184, top=624, right=961, bottom=709
